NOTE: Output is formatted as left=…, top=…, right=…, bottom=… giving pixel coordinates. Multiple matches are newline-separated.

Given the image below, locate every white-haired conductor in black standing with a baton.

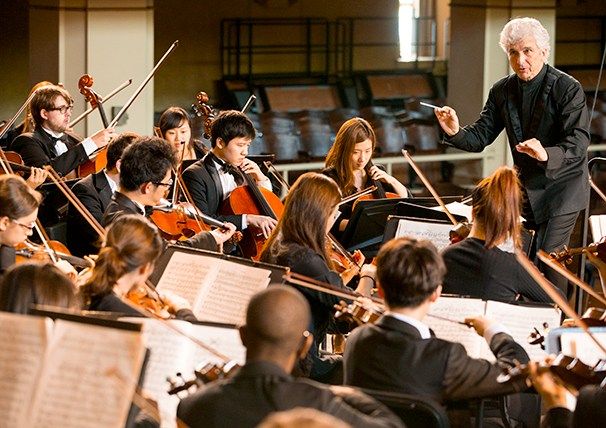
left=435, top=18, right=589, bottom=291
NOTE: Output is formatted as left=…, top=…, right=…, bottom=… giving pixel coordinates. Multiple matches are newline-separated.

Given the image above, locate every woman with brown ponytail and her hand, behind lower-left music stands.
left=80, top=214, right=196, bottom=321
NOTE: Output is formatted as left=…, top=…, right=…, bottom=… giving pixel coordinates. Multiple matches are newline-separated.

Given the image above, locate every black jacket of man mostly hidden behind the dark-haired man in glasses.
left=67, top=171, right=113, bottom=257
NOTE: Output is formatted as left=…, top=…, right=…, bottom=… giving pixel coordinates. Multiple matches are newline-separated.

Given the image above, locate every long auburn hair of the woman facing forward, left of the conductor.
left=325, top=117, right=377, bottom=195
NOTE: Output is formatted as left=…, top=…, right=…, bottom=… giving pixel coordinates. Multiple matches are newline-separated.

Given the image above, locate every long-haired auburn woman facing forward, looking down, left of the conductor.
left=322, top=117, right=409, bottom=232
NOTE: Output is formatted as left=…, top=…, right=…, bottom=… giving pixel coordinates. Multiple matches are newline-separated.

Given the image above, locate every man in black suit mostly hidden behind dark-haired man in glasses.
left=67, top=132, right=139, bottom=257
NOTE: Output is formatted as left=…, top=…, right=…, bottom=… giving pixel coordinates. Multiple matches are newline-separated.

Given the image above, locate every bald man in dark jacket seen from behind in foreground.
left=177, top=286, right=402, bottom=428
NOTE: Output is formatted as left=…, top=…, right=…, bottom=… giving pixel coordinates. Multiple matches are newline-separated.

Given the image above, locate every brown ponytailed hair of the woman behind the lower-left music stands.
left=81, top=215, right=163, bottom=304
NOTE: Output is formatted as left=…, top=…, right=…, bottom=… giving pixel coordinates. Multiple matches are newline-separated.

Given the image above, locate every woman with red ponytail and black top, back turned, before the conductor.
left=442, top=167, right=551, bottom=303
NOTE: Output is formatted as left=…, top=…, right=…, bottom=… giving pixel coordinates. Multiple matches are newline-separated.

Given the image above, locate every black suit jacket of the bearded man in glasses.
left=10, top=126, right=88, bottom=175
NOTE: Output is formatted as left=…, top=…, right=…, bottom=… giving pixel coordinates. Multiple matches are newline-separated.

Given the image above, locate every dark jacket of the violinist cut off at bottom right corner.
left=541, top=385, right=606, bottom=428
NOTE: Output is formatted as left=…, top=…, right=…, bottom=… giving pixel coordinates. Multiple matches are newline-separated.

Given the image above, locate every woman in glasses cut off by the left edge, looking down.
left=0, top=174, right=42, bottom=275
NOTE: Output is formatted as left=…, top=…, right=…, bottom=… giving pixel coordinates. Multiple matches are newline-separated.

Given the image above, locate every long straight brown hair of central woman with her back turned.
left=261, top=172, right=341, bottom=267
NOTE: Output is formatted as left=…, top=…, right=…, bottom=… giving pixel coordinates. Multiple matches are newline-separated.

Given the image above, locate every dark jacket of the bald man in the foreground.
left=177, top=361, right=402, bottom=428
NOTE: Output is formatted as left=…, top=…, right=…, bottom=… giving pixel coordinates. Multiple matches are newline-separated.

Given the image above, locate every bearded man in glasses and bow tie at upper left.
left=10, top=85, right=114, bottom=175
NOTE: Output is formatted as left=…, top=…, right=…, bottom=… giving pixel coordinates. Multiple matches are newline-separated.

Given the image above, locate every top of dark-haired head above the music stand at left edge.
left=0, top=262, right=81, bottom=314
